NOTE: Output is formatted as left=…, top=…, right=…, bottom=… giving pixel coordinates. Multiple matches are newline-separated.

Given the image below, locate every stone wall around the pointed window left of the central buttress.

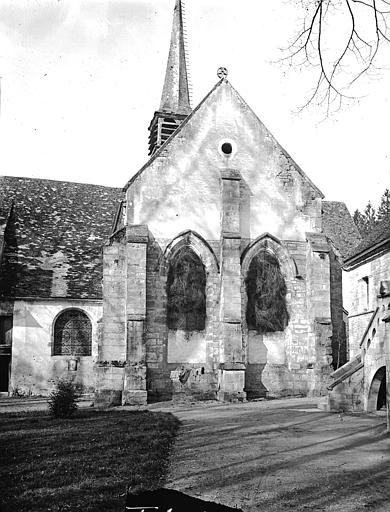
left=145, top=233, right=221, bottom=401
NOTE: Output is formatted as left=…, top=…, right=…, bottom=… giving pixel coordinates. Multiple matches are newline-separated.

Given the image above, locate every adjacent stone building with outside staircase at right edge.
left=323, top=219, right=390, bottom=412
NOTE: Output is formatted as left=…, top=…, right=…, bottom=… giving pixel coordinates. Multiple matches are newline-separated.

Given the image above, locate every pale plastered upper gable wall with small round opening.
left=127, top=83, right=321, bottom=240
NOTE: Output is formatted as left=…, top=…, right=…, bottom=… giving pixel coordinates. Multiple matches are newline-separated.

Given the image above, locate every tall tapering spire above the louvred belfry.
left=160, top=0, right=191, bottom=114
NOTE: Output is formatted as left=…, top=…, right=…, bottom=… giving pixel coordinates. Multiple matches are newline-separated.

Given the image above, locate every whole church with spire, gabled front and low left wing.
left=0, top=0, right=359, bottom=406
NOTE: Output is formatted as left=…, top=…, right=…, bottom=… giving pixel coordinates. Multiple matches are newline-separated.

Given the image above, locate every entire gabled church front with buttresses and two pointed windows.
left=96, top=77, right=334, bottom=405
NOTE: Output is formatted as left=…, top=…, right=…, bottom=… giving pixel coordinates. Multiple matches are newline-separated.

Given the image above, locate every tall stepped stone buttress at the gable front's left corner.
left=95, top=226, right=148, bottom=406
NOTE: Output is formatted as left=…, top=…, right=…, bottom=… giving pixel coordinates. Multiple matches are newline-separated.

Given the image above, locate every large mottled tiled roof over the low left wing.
left=0, top=177, right=122, bottom=299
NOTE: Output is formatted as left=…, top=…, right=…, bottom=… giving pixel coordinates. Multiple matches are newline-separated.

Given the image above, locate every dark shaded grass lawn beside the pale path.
left=0, top=409, right=179, bottom=512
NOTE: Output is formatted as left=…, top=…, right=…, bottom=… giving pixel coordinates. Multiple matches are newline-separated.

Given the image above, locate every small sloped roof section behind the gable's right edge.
left=322, top=201, right=361, bottom=260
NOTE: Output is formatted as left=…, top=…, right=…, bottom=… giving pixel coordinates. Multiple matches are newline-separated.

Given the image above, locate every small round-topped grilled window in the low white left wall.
left=53, top=309, right=92, bottom=356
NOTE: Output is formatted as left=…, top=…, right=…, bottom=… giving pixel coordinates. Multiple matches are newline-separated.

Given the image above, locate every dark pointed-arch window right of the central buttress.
left=245, top=251, right=289, bottom=333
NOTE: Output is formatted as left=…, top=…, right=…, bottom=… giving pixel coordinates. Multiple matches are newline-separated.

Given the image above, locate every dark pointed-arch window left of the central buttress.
left=167, top=247, right=206, bottom=331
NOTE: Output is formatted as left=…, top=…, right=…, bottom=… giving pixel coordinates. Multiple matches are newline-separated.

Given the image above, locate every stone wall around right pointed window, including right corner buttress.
left=242, top=234, right=332, bottom=398
